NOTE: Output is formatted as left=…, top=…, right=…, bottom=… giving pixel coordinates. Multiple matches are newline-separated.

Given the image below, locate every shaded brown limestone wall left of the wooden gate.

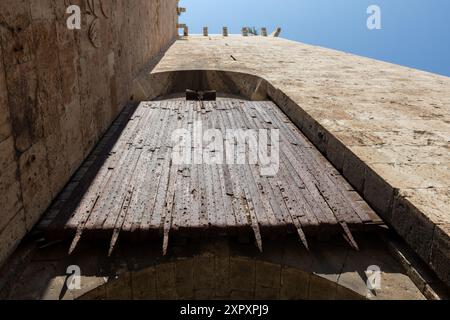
left=0, top=0, right=177, bottom=264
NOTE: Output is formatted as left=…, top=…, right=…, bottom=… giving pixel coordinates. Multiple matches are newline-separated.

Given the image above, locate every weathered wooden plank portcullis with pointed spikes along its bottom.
left=44, top=99, right=376, bottom=254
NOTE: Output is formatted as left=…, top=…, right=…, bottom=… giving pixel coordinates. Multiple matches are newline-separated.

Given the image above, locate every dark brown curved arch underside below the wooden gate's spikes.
left=79, top=255, right=366, bottom=300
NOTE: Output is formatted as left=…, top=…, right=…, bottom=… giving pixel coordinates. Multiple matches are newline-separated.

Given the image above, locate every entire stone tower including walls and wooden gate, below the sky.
left=0, top=0, right=450, bottom=299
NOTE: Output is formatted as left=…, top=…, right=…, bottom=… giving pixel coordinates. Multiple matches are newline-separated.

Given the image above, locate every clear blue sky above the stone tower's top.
left=180, top=0, right=450, bottom=76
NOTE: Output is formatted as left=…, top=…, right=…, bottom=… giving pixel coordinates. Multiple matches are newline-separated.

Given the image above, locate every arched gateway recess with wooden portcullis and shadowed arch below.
left=2, top=75, right=432, bottom=299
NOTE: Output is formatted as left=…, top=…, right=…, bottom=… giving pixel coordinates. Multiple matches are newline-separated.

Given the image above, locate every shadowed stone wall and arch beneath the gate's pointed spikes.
left=2, top=237, right=396, bottom=300
